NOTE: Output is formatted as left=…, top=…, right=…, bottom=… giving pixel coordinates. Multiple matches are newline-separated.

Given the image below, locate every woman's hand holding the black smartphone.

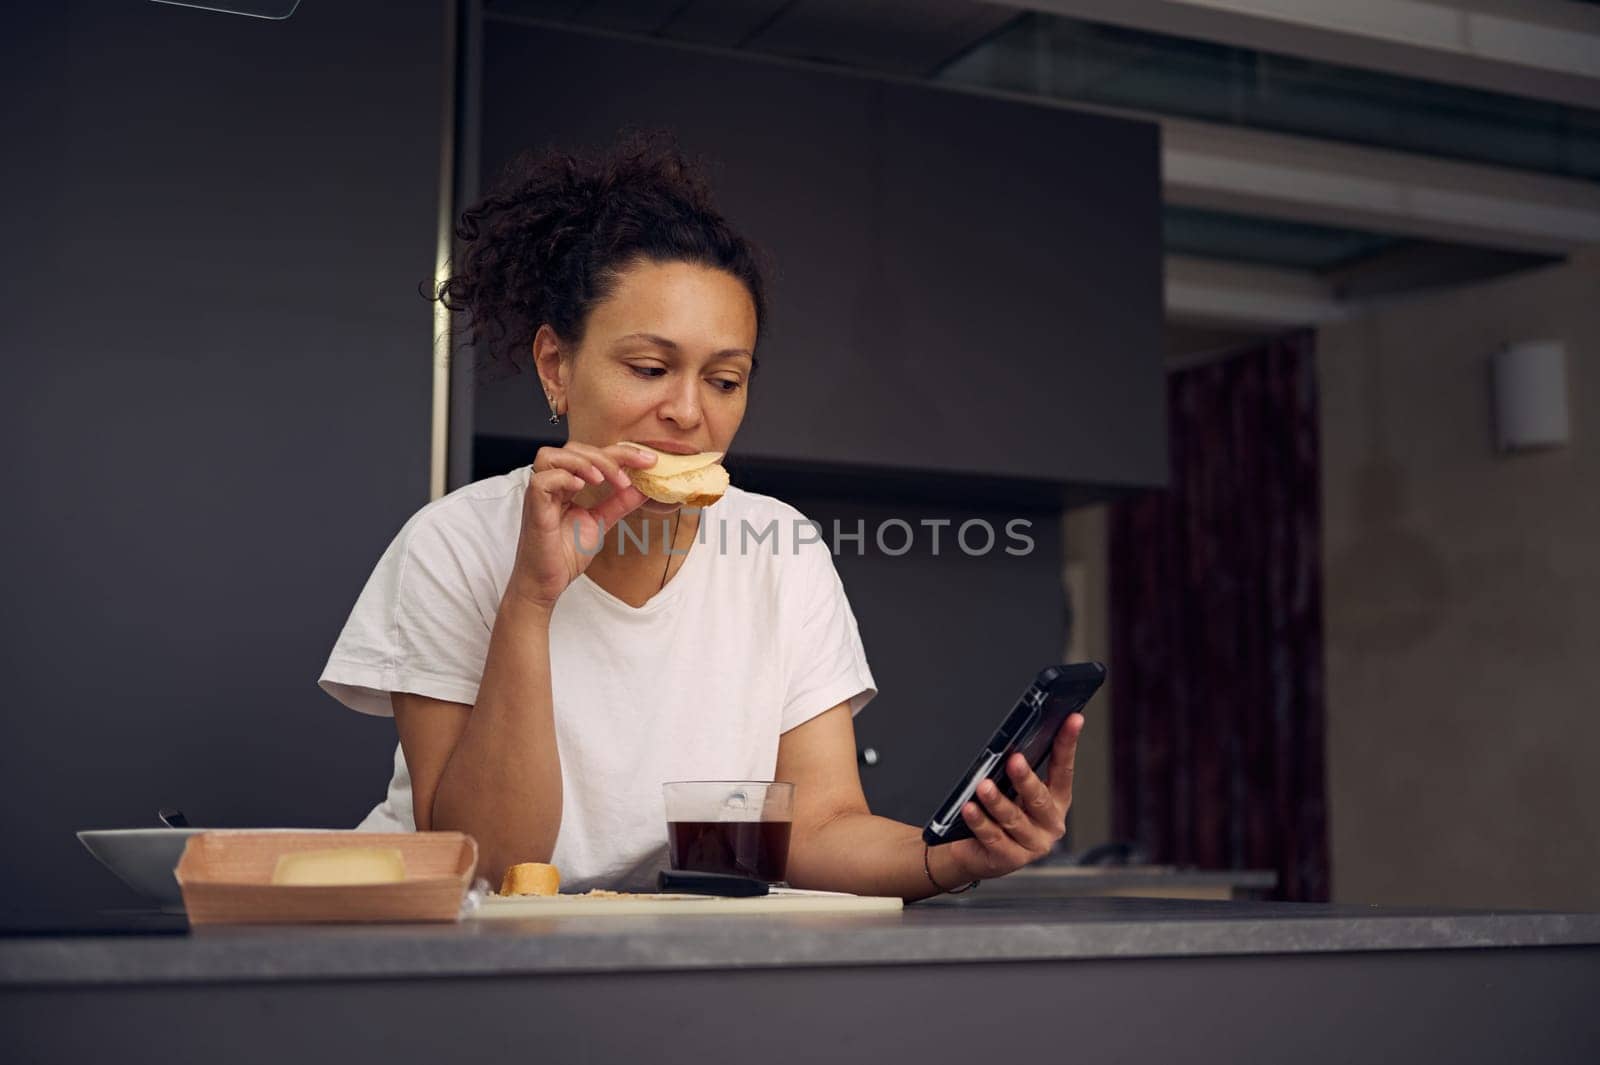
left=930, top=713, right=1083, bottom=888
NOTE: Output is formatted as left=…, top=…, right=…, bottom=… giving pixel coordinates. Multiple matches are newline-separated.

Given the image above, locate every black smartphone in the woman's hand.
left=922, top=662, right=1106, bottom=846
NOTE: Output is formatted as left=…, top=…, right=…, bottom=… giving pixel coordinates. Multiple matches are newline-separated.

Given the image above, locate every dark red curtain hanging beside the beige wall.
left=1110, top=331, right=1328, bottom=902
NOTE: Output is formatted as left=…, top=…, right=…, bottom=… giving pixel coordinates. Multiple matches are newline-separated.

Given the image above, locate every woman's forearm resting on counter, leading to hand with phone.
left=787, top=814, right=960, bottom=902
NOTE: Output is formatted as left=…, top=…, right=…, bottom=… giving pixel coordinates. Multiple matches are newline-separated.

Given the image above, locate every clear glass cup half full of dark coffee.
left=661, top=780, right=795, bottom=884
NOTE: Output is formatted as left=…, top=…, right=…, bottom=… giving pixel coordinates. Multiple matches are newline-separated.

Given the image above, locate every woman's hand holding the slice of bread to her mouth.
left=510, top=443, right=656, bottom=609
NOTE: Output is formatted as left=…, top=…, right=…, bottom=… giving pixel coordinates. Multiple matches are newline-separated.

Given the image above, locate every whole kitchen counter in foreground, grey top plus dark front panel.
left=0, top=894, right=1600, bottom=1063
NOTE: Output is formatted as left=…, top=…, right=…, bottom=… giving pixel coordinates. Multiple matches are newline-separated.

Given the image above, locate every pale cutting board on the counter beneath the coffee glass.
left=467, top=888, right=904, bottom=919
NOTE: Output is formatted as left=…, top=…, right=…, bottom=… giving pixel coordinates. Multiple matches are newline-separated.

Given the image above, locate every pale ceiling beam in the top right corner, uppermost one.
left=1010, top=0, right=1600, bottom=107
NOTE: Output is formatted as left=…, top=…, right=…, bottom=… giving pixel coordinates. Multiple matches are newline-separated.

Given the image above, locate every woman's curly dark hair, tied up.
left=430, top=131, right=766, bottom=373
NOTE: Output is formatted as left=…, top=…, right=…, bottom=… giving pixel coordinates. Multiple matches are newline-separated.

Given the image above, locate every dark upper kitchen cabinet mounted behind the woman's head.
left=475, top=21, right=1165, bottom=499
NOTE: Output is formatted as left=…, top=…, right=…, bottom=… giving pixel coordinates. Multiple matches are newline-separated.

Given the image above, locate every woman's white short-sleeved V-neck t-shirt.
left=320, top=467, right=877, bottom=891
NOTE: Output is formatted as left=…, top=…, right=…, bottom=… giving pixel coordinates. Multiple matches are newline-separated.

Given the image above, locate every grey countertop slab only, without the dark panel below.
left=0, top=895, right=1600, bottom=987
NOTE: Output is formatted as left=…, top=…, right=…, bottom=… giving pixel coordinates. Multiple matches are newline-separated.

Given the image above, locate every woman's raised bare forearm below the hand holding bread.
left=432, top=590, right=562, bottom=884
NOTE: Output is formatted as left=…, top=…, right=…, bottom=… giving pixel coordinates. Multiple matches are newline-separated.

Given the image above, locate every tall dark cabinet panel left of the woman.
left=0, top=0, right=446, bottom=913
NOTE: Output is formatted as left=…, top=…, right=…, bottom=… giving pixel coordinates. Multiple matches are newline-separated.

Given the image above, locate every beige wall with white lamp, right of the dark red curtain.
left=1317, top=256, right=1600, bottom=908
